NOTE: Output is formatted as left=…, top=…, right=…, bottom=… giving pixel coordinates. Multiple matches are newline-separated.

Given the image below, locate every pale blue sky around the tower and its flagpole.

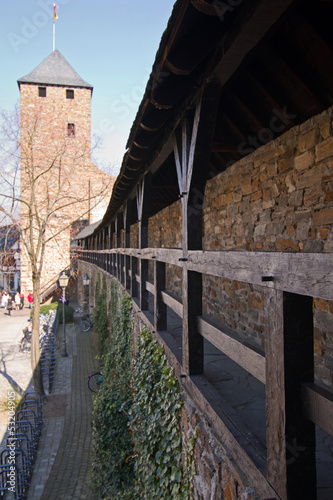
left=0, top=0, right=175, bottom=173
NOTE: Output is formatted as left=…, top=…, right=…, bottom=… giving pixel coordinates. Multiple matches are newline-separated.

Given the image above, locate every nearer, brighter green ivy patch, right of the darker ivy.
left=129, top=328, right=191, bottom=500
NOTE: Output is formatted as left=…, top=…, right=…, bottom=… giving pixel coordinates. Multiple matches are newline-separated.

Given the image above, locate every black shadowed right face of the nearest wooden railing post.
left=283, top=293, right=317, bottom=498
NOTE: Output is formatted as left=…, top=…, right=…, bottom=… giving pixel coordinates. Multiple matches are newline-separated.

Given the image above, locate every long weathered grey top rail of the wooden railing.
left=82, top=248, right=333, bottom=300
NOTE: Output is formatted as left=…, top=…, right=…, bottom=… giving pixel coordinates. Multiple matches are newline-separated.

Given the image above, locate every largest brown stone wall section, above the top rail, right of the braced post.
left=203, top=108, right=333, bottom=252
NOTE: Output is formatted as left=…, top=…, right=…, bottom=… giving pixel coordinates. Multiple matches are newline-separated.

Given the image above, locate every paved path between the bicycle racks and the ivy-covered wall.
left=26, top=310, right=98, bottom=500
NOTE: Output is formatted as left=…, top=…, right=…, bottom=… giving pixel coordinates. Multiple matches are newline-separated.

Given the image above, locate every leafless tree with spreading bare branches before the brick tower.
left=0, top=108, right=113, bottom=393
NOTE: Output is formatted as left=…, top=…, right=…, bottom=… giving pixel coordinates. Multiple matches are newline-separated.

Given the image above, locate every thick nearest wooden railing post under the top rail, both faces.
left=266, top=290, right=316, bottom=500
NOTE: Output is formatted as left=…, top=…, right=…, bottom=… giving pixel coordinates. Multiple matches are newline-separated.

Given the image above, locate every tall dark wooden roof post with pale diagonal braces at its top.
left=174, top=82, right=220, bottom=375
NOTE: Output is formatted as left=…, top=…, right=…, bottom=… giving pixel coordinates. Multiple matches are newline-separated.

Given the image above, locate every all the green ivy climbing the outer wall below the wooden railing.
left=92, top=281, right=195, bottom=500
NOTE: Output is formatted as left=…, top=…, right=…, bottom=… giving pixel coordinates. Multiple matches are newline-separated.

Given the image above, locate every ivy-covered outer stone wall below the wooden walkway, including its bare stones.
left=78, top=262, right=257, bottom=500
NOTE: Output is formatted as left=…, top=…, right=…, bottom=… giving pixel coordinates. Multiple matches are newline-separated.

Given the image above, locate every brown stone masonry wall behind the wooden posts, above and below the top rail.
left=144, top=108, right=333, bottom=386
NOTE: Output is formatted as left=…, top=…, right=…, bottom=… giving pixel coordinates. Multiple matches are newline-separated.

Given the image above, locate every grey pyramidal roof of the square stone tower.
left=17, top=50, right=93, bottom=89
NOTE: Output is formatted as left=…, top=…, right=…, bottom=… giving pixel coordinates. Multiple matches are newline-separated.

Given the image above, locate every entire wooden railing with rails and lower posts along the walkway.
left=80, top=248, right=333, bottom=498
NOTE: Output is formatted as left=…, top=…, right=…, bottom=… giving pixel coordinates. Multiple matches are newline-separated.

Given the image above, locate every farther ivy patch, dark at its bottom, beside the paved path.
left=92, top=295, right=134, bottom=499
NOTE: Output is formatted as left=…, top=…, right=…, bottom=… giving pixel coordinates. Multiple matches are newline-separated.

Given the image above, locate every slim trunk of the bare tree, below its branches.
left=31, top=277, right=45, bottom=395
